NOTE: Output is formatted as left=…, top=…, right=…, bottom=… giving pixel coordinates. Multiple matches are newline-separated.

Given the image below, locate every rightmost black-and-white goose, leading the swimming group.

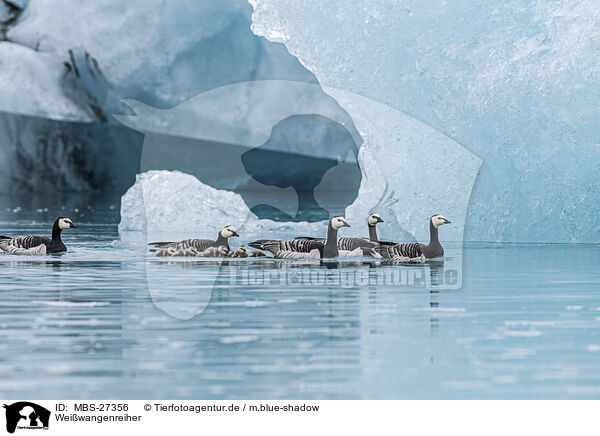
left=375, top=215, right=450, bottom=260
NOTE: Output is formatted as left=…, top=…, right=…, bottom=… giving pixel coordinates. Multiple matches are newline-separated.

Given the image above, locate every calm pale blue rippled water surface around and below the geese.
left=0, top=208, right=600, bottom=399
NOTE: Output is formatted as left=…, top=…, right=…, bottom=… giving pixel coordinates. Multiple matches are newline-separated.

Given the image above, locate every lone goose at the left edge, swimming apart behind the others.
left=0, top=216, right=77, bottom=256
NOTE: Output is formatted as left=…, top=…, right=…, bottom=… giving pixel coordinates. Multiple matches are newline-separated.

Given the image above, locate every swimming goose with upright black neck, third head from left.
left=248, top=216, right=350, bottom=259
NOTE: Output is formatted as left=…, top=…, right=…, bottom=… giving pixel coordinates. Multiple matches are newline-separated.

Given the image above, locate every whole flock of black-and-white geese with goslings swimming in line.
left=0, top=213, right=450, bottom=261
